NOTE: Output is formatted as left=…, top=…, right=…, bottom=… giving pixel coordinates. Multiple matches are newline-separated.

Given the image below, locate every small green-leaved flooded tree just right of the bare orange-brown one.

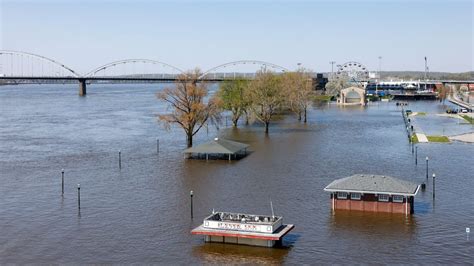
left=217, top=78, right=249, bottom=127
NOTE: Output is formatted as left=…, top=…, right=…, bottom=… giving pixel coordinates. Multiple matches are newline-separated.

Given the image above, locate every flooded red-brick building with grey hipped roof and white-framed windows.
left=324, top=175, right=420, bottom=214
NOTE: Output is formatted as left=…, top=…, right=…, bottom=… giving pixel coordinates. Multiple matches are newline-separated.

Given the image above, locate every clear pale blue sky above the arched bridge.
left=0, top=0, right=474, bottom=73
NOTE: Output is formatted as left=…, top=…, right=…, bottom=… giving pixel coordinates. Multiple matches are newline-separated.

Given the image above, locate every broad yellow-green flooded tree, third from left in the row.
left=246, top=71, right=285, bottom=133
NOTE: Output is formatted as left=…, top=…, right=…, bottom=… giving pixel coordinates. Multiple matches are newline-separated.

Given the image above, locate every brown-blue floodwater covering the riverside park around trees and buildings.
left=0, top=84, right=474, bottom=264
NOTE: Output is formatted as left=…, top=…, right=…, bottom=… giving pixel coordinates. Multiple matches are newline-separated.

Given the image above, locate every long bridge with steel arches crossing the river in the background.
left=0, top=50, right=289, bottom=96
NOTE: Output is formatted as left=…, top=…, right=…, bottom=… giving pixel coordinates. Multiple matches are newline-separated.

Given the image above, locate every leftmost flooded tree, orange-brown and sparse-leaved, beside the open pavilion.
left=156, top=69, right=218, bottom=148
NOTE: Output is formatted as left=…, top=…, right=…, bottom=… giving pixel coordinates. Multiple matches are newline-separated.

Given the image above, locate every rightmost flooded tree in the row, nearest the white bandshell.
left=283, top=68, right=313, bottom=123
